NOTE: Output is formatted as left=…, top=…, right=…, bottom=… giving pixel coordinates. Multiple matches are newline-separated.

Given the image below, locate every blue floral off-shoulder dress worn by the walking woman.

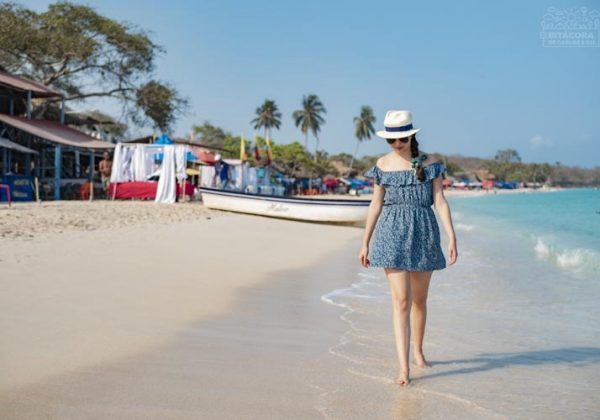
left=364, top=162, right=446, bottom=271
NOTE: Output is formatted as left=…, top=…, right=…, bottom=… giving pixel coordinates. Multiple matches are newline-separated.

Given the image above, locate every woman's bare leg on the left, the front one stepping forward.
left=385, top=269, right=412, bottom=386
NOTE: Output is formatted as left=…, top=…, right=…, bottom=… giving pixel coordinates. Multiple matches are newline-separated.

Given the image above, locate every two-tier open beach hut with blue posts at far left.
left=0, top=71, right=114, bottom=200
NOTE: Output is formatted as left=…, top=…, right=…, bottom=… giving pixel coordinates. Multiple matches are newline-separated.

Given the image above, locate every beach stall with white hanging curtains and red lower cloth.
left=108, top=139, right=194, bottom=203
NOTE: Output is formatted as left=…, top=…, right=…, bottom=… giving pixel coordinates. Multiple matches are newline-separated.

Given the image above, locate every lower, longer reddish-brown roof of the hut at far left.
left=0, top=114, right=115, bottom=149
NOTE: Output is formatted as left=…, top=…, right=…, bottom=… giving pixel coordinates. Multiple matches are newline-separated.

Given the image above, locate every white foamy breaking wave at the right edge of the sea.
left=534, top=238, right=600, bottom=274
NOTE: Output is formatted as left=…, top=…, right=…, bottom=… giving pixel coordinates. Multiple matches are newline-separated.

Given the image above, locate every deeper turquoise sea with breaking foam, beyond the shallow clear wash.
left=450, top=188, right=600, bottom=278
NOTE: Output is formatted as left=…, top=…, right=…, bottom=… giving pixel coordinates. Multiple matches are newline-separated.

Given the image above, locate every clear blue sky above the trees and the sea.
left=23, top=0, right=600, bottom=167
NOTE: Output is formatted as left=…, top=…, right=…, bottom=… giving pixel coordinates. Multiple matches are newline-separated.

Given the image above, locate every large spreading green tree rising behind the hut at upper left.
left=0, top=2, right=187, bottom=128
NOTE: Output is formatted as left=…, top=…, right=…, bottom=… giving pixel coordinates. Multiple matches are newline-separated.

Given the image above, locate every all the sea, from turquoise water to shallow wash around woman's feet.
left=322, top=189, right=600, bottom=419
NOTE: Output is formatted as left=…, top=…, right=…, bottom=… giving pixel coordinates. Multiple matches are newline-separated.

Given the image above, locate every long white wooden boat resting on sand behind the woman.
left=199, top=187, right=370, bottom=224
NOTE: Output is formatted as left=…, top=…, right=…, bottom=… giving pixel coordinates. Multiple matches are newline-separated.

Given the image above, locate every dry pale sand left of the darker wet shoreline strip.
left=0, top=202, right=361, bottom=418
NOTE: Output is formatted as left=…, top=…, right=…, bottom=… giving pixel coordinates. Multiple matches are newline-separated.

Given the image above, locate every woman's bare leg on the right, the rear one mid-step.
left=410, top=271, right=432, bottom=367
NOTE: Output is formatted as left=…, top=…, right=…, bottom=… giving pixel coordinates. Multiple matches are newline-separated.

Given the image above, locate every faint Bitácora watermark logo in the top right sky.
left=540, top=7, right=600, bottom=47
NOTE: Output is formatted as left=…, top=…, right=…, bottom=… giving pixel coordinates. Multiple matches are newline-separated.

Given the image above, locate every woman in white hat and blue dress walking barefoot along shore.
left=359, top=111, right=457, bottom=386
